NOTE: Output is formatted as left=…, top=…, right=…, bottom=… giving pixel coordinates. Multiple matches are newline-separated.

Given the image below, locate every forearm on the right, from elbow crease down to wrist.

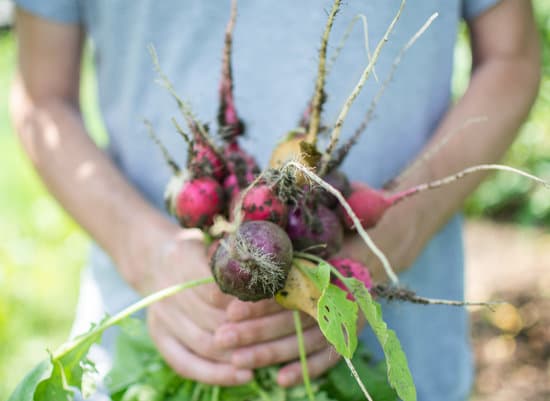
left=345, top=7, right=540, bottom=280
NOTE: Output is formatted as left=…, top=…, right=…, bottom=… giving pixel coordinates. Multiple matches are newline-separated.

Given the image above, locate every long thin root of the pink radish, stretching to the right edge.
left=388, top=164, right=550, bottom=205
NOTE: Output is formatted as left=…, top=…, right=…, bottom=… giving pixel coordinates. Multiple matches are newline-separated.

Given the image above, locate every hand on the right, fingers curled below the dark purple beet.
left=214, top=299, right=339, bottom=387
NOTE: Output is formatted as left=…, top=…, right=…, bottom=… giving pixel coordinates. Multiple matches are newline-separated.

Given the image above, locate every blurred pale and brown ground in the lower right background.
left=465, top=221, right=550, bottom=401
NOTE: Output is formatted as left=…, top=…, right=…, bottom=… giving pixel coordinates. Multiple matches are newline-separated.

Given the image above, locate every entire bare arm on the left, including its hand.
left=11, top=10, right=251, bottom=385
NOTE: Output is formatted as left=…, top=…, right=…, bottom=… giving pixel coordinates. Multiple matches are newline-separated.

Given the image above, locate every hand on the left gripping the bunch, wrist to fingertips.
left=125, top=225, right=252, bottom=386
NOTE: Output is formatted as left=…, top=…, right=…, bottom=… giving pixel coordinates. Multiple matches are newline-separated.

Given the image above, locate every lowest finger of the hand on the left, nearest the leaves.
left=151, top=316, right=252, bottom=386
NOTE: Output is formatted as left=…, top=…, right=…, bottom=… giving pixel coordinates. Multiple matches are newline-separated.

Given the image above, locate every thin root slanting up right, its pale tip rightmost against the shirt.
left=327, top=13, right=439, bottom=172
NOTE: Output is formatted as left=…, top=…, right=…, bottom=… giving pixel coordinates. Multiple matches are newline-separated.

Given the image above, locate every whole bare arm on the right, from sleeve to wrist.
left=342, top=0, right=540, bottom=280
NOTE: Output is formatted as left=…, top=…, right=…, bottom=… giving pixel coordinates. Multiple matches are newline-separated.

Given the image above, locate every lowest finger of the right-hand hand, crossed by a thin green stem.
left=277, top=346, right=340, bottom=387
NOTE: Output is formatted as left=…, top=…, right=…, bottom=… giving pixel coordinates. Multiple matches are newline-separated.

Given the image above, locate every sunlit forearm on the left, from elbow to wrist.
left=12, top=79, right=175, bottom=291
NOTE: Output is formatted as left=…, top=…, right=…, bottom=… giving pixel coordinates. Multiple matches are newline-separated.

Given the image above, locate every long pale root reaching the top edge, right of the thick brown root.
left=320, top=0, right=406, bottom=175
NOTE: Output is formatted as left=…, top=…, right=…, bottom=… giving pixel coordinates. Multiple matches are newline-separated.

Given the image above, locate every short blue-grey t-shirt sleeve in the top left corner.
left=14, top=0, right=80, bottom=24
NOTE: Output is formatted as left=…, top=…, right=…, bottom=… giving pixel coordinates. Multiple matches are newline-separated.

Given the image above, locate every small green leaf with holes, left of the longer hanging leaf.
left=317, top=284, right=357, bottom=358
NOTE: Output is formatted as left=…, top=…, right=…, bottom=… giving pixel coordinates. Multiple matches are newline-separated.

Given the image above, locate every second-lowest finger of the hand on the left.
left=153, top=307, right=231, bottom=362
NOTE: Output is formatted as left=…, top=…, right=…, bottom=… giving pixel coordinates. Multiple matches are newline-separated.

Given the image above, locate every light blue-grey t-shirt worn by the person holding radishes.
left=16, top=0, right=498, bottom=401
